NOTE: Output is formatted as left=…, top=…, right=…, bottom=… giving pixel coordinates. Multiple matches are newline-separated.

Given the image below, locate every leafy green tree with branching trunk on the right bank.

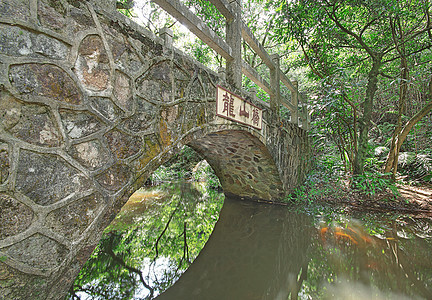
left=273, top=0, right=432, bottom=174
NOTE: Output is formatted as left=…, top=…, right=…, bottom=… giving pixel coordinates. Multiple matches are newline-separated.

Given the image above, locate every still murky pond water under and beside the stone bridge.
left=68, top=182, right=432, bottom=300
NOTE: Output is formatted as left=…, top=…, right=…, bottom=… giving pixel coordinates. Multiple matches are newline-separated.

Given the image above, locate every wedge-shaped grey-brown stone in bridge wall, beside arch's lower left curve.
left=46, top=194, right=104, bottom=239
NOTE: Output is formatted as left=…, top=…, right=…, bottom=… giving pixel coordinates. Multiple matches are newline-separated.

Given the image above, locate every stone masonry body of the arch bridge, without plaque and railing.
left=0, top=0, right=309, bottom=299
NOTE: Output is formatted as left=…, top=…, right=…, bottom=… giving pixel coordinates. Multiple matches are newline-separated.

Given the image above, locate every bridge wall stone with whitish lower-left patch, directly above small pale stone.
left=60, top=109, right=103, bottom=139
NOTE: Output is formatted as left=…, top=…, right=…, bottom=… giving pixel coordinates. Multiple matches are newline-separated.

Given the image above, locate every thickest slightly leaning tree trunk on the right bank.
left=353, top=54, right=382, bottom=175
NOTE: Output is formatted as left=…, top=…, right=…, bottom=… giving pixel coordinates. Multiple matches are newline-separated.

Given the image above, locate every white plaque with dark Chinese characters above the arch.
left=216, top=86, right=262, bottom=130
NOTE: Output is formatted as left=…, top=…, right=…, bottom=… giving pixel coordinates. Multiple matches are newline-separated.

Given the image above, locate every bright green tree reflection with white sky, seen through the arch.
left=69, top=183, right=223, bottom=299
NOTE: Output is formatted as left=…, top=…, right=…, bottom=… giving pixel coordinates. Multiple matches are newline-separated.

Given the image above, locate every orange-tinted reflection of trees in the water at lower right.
left=303, top=216, right=432, bottom=299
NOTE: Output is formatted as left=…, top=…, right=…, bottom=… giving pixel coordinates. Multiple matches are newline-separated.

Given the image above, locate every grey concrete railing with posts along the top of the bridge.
left=152, top=0, right=310, bottom=130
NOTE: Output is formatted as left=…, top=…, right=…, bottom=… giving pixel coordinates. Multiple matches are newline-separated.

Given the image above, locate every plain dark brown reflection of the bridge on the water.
left=157, top=199, right=311, bottom=300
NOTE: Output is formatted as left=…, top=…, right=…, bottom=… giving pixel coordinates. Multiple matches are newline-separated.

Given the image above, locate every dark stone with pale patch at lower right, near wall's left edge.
left=6, top=105, right=62, bottom=147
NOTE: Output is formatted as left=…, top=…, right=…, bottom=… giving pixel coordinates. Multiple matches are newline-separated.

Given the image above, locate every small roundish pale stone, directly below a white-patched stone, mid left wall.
left=70, top=140, right=110, bottom=170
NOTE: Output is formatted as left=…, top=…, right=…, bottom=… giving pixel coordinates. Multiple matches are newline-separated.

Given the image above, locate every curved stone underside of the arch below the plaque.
left=188, top=130, right=283, bottom=200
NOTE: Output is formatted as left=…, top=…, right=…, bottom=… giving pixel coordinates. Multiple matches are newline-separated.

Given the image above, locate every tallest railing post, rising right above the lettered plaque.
left=226, top=0, right=242, bottom=90
